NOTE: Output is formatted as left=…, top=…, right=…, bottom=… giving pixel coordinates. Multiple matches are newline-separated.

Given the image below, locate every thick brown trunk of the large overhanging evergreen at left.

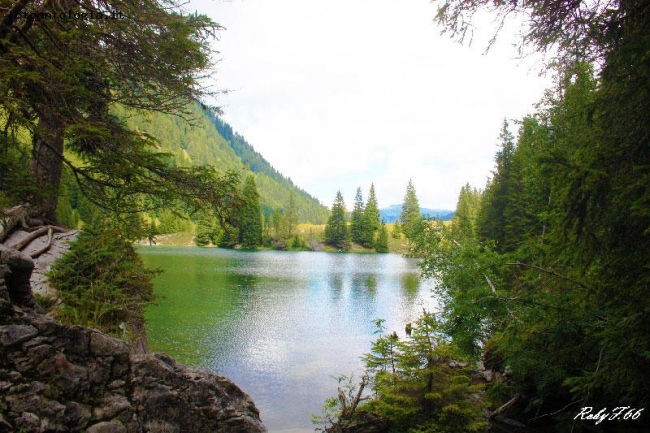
left=29, top=107, right=64, bottom=223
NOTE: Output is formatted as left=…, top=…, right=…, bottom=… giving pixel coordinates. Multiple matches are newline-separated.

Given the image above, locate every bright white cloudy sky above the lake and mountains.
left=186, top=0, right=551, bottom=210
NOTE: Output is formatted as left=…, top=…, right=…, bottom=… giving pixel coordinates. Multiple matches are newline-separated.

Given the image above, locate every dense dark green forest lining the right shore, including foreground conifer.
left=320, top=0, right=650, bottom=432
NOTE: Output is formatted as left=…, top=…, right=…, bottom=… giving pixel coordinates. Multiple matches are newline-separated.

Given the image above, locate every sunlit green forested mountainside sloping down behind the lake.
left=114, top=104, right=328, bottom=224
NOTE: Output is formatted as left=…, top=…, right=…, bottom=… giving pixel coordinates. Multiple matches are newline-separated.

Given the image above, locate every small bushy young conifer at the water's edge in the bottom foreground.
left=318, top=311, right=487, bottom=433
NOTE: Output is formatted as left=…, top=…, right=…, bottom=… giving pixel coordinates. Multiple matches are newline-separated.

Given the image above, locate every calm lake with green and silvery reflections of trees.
left=138, top=246, right=436, bottom=433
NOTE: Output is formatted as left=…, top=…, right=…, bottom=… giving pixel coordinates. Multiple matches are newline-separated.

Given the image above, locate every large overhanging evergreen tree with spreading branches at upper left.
left=0, top=0, right=236, bottom=221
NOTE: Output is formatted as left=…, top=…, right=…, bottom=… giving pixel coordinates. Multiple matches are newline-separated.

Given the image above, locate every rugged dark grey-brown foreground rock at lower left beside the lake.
left=0, top=245, right=266, bottom=433
